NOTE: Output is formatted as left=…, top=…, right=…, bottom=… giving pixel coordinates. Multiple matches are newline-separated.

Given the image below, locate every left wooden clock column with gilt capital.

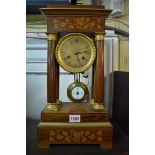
left=47, top=33, right=59, bottom=103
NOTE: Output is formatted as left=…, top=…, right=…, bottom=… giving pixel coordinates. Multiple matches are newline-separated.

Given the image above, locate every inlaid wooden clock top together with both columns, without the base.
left=40, top=4, right=112, bottom=103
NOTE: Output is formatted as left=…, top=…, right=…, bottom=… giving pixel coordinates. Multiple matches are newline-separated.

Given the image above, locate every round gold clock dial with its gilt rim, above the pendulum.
left=56, top=33, right=96, bottom=73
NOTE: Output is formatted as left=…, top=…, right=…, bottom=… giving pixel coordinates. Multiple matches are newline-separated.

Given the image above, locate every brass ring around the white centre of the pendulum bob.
left=67, top=82, right=88, bottom=103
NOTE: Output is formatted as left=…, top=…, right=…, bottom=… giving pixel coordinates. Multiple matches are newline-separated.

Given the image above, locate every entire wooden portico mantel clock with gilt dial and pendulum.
left=37, top=5, right=113, bottom=149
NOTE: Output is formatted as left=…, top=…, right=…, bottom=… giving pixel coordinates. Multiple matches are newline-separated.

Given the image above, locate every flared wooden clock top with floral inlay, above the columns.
left=40, top=4, right=112, bottom=33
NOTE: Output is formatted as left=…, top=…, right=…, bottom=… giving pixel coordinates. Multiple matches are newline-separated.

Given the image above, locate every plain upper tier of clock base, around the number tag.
left=41, top=103, right=109, bottom=122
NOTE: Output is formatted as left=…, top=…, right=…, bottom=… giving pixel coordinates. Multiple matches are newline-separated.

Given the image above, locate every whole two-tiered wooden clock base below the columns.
left=37, top=103, right=113, bottom=149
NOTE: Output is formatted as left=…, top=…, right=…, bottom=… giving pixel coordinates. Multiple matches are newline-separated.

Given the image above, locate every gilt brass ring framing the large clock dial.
left=55, top=33, right=96, bottom=73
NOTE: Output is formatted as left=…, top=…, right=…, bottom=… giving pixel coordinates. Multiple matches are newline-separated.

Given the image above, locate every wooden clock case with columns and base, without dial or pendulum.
left=37, top=4, right=113, bottom=149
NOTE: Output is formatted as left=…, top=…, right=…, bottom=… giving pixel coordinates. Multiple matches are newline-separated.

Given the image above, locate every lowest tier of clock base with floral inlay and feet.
left=37, top=122, right=112, bottom=149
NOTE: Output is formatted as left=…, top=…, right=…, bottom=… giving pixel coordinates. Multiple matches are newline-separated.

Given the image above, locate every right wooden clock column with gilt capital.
left=93, top=32, right=105, bottom=104
